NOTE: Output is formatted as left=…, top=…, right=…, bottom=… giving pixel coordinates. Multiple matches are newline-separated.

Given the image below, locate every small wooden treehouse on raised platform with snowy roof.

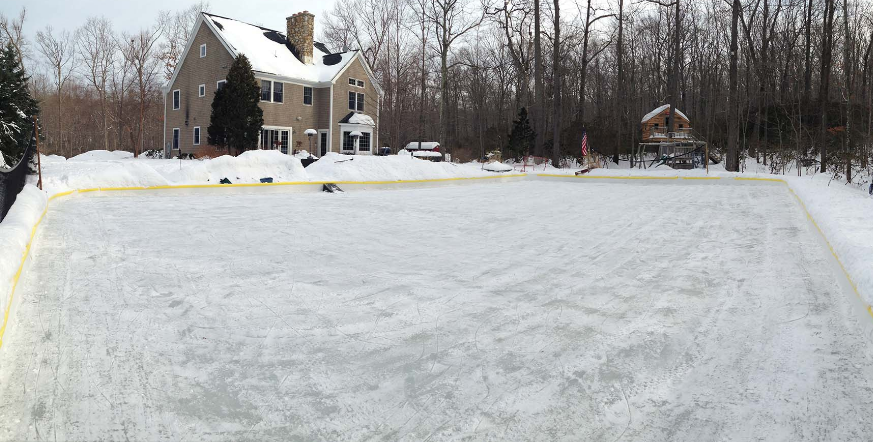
left=640, top=104, right=706, bottom=169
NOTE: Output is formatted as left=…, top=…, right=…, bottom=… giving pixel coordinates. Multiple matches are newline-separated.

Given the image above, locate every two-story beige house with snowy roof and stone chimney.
left=163, top=11, right=382, bottom=156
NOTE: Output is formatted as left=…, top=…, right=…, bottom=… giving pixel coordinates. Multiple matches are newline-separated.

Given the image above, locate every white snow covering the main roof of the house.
left=203, top=12, right=357, bottom=83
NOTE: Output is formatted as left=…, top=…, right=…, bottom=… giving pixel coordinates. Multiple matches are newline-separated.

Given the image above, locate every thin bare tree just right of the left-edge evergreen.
left=36, top=26, right=76, bottom=156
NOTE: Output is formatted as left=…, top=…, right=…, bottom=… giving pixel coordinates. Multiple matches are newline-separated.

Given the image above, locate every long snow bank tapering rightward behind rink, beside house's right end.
left=306, top=153, right=493, bottom=182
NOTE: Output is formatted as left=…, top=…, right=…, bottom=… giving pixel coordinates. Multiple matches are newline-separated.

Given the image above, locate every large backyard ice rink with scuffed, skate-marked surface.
left=0, top=181, right=873, bottom=441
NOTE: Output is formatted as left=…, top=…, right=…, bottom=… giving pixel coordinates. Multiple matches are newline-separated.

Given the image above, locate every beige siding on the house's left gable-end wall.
left=165, top=23, right=233, bottom=157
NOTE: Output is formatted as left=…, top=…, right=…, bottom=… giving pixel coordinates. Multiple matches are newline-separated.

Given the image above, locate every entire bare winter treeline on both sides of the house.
left=0, top=0, right=873, bottom=179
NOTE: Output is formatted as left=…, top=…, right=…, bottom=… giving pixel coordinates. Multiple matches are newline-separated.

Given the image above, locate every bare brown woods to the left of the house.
left=0, top=3, right=207, bottom=157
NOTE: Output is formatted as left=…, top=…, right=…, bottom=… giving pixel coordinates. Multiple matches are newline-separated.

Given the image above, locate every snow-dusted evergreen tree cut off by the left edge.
left=0, top=43, right=39, bottom=167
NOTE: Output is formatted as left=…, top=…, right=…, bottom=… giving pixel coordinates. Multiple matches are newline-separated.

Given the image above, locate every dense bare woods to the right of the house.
left=320, top=0, right=873, bottom=178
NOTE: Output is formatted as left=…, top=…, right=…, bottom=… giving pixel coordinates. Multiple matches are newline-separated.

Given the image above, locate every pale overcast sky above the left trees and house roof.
left=0, top=0, right=333, bottom=41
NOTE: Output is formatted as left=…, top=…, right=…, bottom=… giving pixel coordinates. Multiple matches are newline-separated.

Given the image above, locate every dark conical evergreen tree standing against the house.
left=207, top=54, right=264, bottom=154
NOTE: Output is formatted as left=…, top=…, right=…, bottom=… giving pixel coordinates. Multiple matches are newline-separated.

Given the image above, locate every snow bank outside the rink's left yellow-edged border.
left=0, top=185, right=48, bottom=321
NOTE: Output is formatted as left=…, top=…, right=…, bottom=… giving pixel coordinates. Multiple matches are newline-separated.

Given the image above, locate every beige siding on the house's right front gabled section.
left=331, top=58, right=379, bottom=153
